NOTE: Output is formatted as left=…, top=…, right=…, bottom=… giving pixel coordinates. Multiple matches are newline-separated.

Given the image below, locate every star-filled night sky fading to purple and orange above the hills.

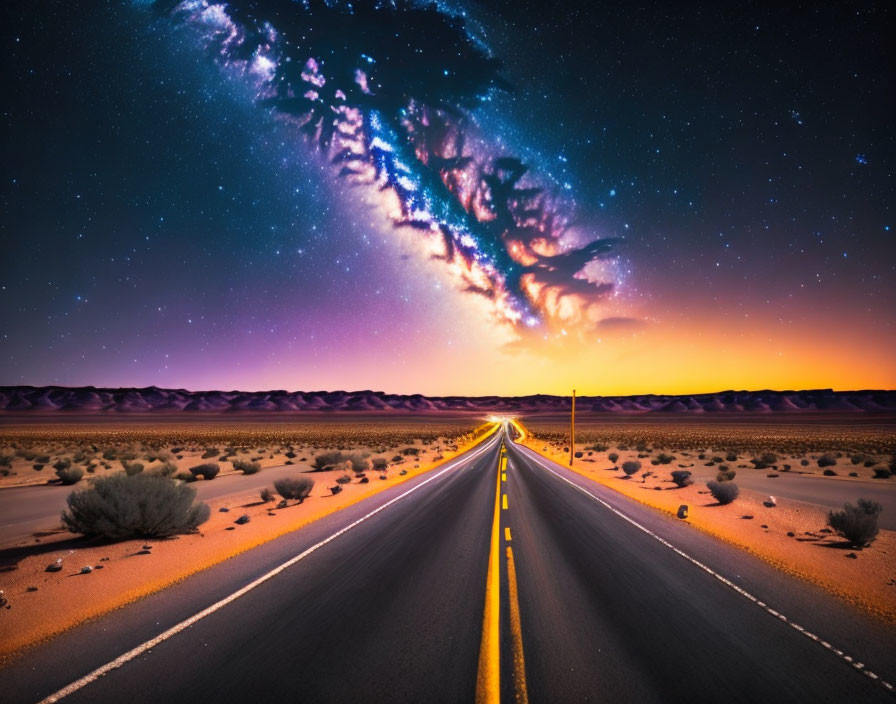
left=0, top=0, right=896, bottom=395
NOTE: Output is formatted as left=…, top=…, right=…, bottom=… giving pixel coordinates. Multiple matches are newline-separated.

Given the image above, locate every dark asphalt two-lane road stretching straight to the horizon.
left=0, top=426, right=896, bottom=704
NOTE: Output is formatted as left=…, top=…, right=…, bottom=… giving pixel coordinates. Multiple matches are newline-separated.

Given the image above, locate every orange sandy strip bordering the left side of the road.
left=0, top=426, right=497, bottom=661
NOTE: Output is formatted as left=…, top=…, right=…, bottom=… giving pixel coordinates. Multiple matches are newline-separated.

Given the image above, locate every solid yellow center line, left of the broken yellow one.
left=476, top=445, right=506, bottom=704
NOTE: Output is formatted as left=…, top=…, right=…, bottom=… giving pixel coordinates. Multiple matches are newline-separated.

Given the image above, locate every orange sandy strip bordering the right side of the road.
left=523, top=424, right=896, bottom=623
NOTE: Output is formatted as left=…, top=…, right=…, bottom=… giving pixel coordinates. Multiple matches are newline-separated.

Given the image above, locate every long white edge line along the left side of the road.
left=39, top=433, right=499, bottom=704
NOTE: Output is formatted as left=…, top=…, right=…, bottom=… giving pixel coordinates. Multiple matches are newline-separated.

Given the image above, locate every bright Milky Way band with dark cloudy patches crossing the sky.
left=154, top=0, right=617, bottom=335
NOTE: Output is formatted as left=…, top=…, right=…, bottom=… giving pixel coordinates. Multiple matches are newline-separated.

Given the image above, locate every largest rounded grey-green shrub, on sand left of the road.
left=62, top=474, right=209, bottom=540
